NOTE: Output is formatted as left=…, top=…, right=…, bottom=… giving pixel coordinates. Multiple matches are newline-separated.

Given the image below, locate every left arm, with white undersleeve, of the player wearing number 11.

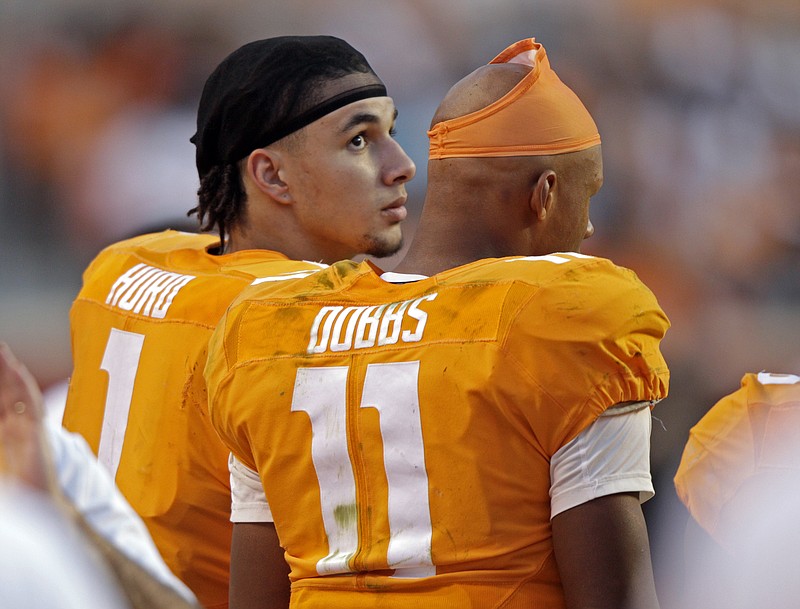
left=228, top=456, right=290, bottom=609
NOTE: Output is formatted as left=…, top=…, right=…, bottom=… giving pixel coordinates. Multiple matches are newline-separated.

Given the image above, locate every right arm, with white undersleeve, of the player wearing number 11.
left=551, top=402, right=659, bottom=609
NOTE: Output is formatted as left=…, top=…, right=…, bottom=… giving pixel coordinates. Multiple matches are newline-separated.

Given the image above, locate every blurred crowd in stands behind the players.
left=0, top=0, right=800, bottom=609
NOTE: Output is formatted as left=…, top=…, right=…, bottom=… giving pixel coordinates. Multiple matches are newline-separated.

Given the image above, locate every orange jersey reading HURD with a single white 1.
left=64, top=231, right=320, bottom=608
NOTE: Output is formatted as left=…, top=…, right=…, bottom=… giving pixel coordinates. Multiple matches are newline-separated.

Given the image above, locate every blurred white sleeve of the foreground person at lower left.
left=45, top=418, right=197, bottom=603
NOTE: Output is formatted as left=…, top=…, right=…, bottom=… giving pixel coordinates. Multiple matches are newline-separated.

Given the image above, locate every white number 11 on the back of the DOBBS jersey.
left=292, top=361, right=436, bottom=578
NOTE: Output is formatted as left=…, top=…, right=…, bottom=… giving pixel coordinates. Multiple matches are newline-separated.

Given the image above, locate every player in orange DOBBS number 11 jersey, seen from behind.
left=206, top=39, right=669, bottom=609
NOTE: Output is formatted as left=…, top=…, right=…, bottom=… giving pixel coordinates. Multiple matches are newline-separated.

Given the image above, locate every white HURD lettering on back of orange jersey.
left=106, top=263, right=195, bottom=319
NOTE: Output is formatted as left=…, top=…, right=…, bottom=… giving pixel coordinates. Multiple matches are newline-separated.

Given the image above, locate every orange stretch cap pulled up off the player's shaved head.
left=428, top=38, right=600, bottom=159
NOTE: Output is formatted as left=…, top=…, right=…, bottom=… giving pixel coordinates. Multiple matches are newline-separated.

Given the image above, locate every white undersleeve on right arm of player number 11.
left=550, top=402, right=655, bottom=518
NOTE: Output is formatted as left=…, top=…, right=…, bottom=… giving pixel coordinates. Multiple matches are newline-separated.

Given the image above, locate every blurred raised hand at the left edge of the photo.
left=0, top=343, right=59, bottom=496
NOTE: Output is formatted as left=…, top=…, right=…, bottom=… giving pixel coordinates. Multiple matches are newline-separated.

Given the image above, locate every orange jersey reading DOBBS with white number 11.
left=206, top=254, right=669, bottom=609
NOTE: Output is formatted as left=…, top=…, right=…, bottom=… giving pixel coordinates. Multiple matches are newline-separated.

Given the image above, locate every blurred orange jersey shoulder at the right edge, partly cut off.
left=675, top=372, right=800, bottom=550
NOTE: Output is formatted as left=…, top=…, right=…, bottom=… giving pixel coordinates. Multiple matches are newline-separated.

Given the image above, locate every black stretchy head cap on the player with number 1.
left=191, top=36, right=386, bottom=175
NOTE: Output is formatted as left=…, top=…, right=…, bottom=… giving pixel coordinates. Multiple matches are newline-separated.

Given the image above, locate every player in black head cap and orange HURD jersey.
left=64, top=36, right=415, bottom=609
